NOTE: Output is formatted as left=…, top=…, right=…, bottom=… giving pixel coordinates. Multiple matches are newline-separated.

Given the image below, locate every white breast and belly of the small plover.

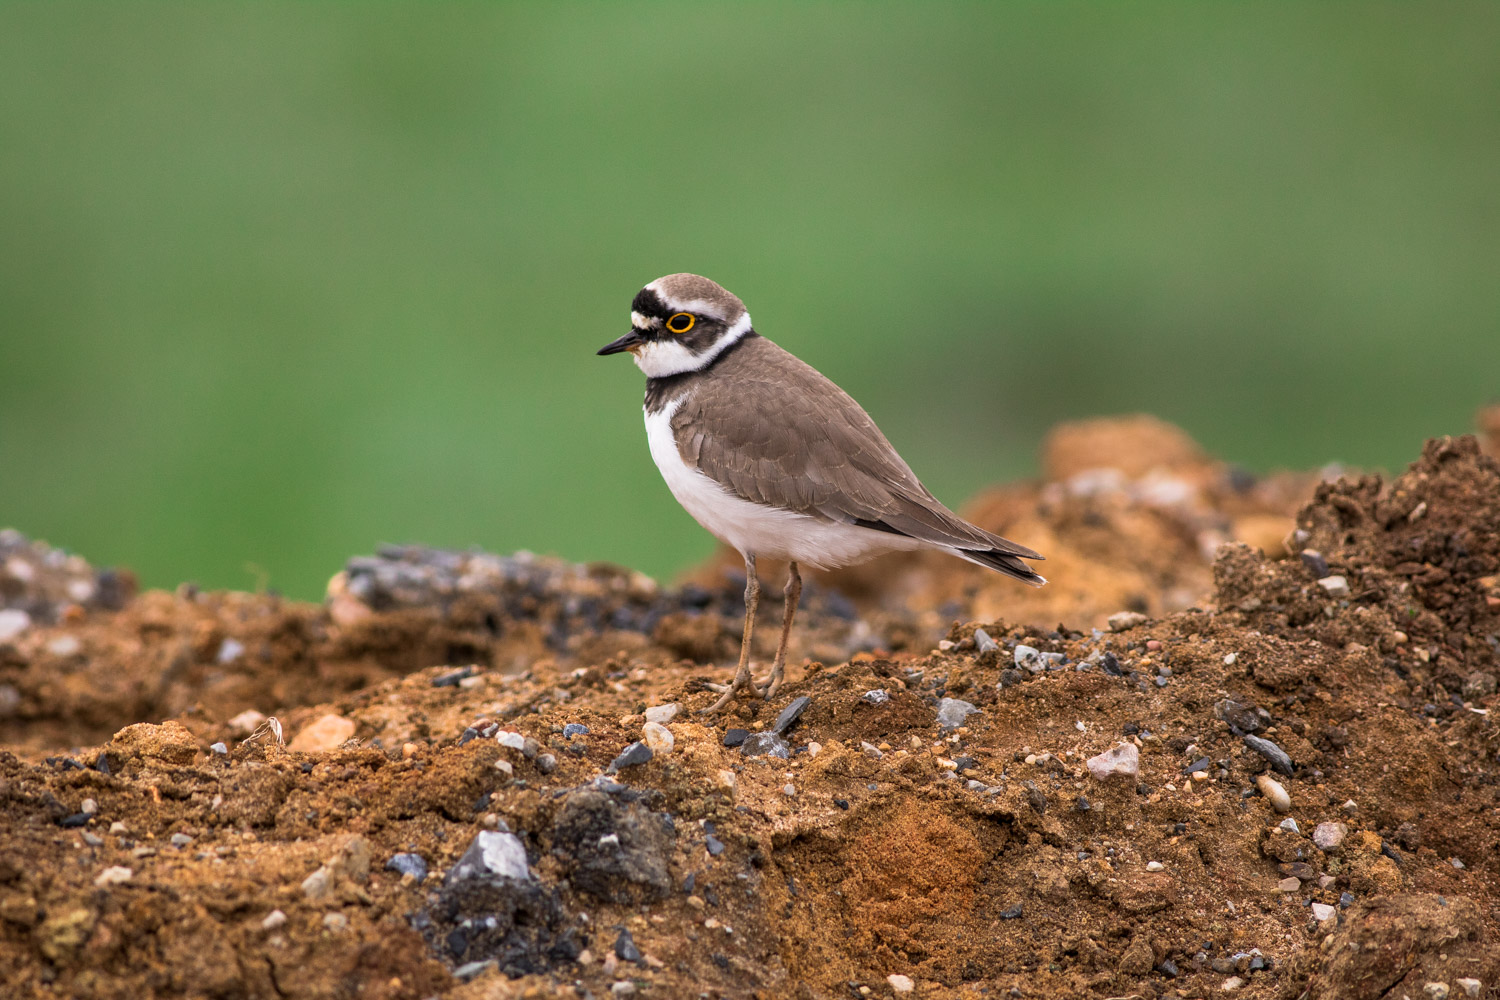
left=647, top=399, right=921, bottom=570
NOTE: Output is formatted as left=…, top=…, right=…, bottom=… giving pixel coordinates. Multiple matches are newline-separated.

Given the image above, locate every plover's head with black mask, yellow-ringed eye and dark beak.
left=599, top=274, right=752, bottom=378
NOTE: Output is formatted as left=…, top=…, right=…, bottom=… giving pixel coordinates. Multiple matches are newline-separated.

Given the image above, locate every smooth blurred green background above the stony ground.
left=0, top=3, right=1500, bottom=597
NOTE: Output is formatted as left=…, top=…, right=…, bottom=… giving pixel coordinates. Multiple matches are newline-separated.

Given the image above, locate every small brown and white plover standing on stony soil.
left=599, top=273, right=1047, bottom=714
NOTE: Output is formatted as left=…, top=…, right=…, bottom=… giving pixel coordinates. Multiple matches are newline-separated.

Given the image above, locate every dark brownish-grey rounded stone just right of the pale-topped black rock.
left=552, top=787, right=675, bottom=904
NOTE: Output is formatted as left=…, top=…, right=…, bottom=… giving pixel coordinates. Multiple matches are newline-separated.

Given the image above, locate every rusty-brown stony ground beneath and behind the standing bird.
left=0, top=415, right=1500, bottom=1000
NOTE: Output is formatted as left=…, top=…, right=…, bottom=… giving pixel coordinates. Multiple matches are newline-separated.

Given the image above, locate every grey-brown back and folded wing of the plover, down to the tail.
left=672, top=337, right=1043, bottom=563
